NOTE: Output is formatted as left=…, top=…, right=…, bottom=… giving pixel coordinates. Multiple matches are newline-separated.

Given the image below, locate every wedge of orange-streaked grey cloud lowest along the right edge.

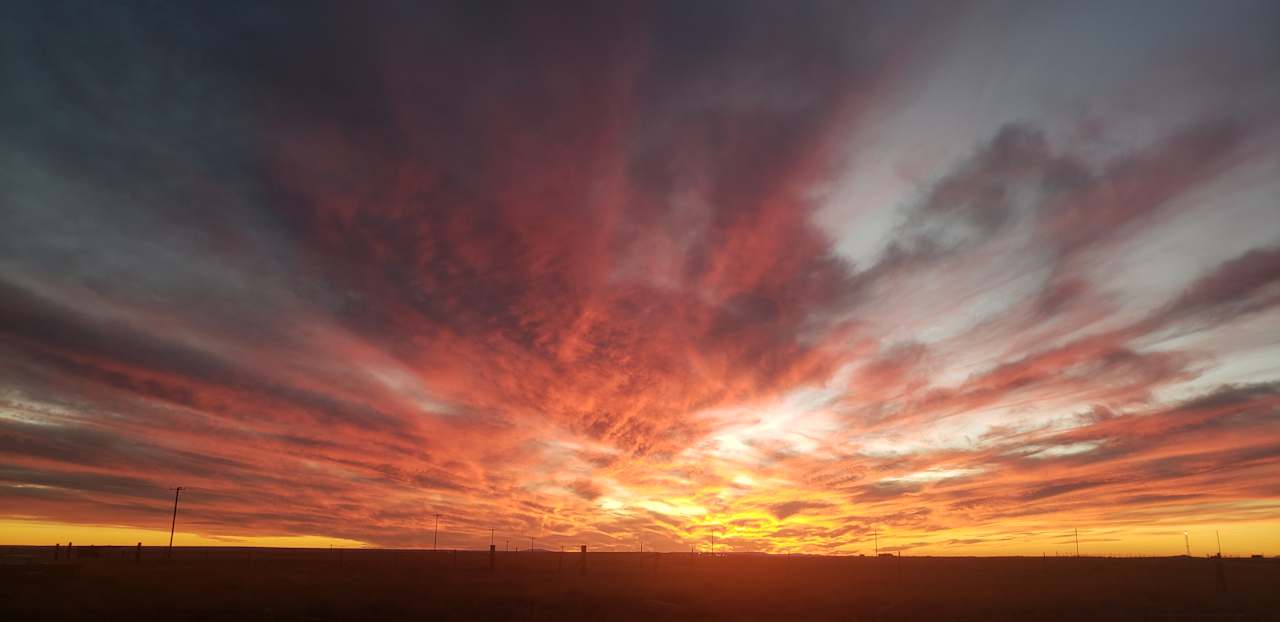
left=880, top=383, right=1280, bottom=520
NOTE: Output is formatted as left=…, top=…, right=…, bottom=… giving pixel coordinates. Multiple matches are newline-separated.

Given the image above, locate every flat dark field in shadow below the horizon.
left=0, top=549, right=1280, bottom=621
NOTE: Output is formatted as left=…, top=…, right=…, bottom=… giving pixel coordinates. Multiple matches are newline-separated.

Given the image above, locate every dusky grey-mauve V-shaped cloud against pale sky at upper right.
left=855, top=119, right=1248, bottom=299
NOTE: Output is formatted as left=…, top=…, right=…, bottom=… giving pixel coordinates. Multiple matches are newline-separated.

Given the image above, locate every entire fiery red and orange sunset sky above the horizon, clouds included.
left=0, top=0, right=1280, bottom=555
